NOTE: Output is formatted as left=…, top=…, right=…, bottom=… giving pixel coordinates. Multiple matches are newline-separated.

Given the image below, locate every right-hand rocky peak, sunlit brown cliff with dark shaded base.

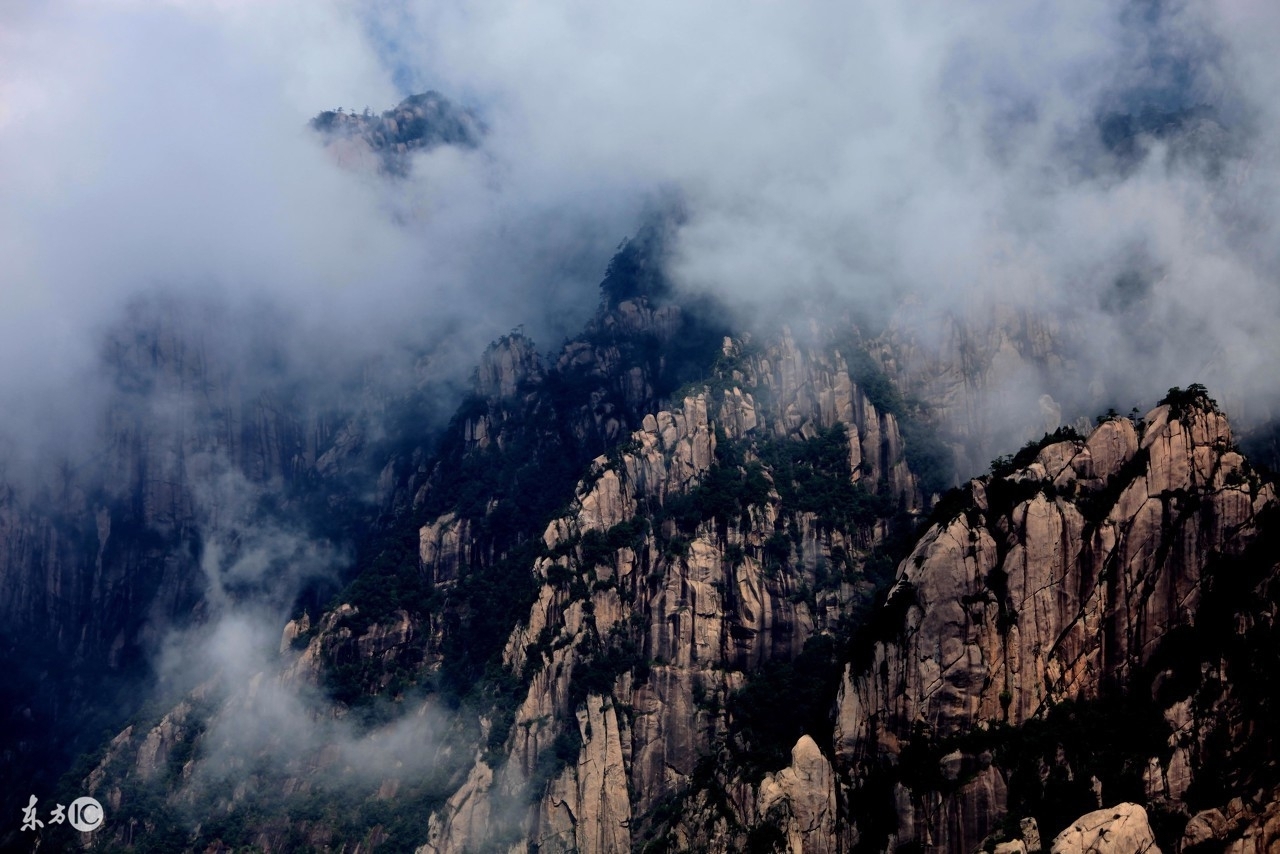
left=837, top=388, right=1280, bottom=850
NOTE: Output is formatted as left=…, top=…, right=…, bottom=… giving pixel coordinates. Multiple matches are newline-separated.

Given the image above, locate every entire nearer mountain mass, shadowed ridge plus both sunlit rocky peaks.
left=15, top=224, right=1280, bottom=854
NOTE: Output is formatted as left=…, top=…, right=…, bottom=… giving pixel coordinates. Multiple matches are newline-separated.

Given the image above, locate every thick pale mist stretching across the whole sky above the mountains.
left=0, top=0, right=1280, bottom=468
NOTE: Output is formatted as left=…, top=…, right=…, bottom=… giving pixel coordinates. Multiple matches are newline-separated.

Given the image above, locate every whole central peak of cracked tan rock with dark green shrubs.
left=422, top=333, right=920, bottom=851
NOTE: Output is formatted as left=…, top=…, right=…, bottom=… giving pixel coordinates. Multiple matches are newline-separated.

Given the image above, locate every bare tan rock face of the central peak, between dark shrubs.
left=421, top=325, right=920, bottom=851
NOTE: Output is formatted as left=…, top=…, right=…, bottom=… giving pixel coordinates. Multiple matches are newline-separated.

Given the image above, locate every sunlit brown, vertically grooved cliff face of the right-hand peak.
left=841, top=407, right=1275, bottom=750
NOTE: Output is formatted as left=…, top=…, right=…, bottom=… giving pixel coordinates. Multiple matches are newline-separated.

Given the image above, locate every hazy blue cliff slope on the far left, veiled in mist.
left=0, top=300, right=399, bottom=850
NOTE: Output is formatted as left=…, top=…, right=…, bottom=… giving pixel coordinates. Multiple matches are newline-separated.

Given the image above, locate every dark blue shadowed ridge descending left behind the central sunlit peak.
left=55, top=230, right=747, bottom=845
